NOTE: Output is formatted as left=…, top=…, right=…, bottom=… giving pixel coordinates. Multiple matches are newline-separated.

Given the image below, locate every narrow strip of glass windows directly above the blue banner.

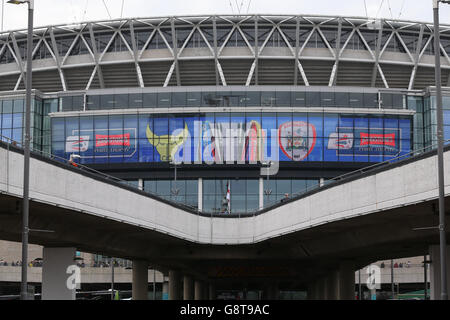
left=81, top=90, right=394, bottom=111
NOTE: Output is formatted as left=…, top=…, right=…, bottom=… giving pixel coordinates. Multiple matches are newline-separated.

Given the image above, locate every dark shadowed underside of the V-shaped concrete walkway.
left=0, top=191, right=450, bottom=287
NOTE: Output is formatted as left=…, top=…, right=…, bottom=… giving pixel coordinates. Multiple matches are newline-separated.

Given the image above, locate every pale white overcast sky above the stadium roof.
left=0, top=0, right=450, bottom=30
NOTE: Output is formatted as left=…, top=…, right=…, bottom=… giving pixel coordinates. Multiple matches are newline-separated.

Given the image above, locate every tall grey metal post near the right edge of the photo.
left=433, top=0, right=448, bottom=300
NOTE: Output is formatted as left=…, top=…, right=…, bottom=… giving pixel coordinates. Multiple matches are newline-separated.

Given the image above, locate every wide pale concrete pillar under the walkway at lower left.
left=41, top=248, right=76, bottom=300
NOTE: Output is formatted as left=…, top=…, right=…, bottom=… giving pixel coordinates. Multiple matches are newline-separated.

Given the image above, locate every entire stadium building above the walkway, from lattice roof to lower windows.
left=0, top=15, right=450, bottom=298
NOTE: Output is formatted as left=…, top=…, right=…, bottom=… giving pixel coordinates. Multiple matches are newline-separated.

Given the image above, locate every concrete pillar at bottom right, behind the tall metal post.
left=429, top=245, right=450, bottom=300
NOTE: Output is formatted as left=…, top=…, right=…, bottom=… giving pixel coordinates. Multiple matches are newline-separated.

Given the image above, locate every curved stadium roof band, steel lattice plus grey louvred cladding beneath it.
left=0, top=15, right=450, bottom=92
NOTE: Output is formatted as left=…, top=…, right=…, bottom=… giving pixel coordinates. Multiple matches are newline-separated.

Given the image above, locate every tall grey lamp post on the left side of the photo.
left=8, top=0, right=34, bottom=300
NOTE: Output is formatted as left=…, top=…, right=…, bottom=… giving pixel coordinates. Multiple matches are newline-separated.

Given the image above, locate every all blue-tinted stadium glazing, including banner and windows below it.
left=0, top=87, right=450, bottom=214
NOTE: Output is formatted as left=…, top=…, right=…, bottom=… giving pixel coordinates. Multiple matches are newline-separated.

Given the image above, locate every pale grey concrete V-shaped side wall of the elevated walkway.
left=0, top=143, right=450, bottom=245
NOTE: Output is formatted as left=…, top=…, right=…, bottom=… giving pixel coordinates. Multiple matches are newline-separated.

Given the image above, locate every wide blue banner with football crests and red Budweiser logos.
left=52, top=113, right=412, bottom=163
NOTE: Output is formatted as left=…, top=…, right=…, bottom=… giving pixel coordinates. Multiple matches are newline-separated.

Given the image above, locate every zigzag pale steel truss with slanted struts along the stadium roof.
left=0, top=15, right=450, bottom=91
